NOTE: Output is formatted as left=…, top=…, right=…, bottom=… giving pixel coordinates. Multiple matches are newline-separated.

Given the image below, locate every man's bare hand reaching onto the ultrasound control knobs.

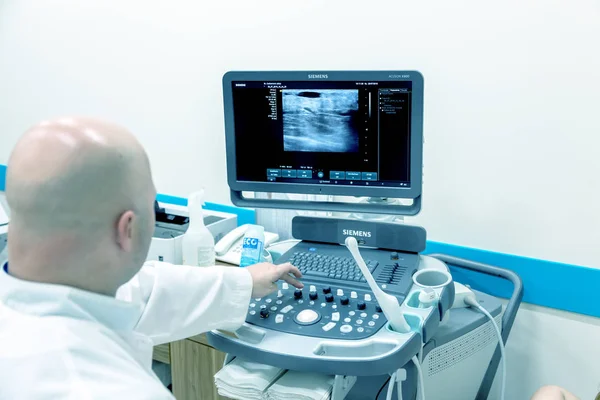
left=246, top=263, right=304, bottom=297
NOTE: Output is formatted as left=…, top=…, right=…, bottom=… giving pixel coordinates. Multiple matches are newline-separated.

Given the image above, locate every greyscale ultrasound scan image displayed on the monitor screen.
left=282, top=89, right=358, bottom=153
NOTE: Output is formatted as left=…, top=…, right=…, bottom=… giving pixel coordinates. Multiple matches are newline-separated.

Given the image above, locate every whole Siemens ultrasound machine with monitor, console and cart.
left=208, top=71, right=523, bottom=400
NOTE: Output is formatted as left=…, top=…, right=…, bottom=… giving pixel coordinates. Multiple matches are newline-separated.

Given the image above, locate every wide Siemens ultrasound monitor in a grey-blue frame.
left=223, top=71, right=423, bottom=215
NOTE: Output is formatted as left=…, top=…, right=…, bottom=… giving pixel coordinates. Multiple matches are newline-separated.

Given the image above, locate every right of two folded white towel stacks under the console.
left=265, top=371, right=334, bottom=400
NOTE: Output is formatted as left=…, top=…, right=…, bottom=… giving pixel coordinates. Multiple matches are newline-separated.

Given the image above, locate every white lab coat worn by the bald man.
left=0, top=262, right=252, bottom=400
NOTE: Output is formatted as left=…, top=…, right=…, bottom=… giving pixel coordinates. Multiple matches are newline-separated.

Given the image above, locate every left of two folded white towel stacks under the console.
left=215, top=357, right=285, bottom=400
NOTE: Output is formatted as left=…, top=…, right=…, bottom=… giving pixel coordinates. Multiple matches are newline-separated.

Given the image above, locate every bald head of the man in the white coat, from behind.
left=6, top=118, right=155, bottom=296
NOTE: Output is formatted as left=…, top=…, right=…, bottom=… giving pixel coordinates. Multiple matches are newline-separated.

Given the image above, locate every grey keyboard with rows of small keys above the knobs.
left=289, top=251, right=379, bottom=282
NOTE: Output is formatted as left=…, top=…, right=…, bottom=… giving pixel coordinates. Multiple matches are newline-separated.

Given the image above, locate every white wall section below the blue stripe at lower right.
left=500, top=304, right=600, bottom=400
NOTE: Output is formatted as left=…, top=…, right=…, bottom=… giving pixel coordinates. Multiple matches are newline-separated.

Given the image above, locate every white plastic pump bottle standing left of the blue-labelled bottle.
left=181, top=190, right=215, bottom=267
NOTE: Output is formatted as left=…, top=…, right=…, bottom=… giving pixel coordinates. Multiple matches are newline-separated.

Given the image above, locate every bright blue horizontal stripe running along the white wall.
left=0, top=165, right=600, bottom=317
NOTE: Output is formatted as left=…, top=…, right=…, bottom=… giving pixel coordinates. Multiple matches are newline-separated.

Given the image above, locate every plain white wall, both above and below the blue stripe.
left=0, top=0, right=600, bottom=399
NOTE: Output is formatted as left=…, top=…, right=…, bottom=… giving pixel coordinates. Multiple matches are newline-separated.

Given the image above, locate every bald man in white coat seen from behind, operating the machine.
left=0, top=118, right=302, bottom=399
